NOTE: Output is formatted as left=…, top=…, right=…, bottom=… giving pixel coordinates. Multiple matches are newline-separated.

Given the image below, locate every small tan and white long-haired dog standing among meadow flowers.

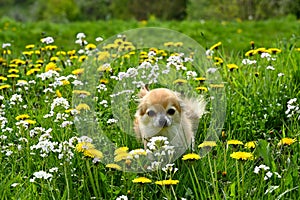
left=134, top=87, right=206, bottom=150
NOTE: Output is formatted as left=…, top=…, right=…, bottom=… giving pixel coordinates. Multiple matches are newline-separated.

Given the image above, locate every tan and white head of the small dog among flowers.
left=136, top=88, right=182, bottom=138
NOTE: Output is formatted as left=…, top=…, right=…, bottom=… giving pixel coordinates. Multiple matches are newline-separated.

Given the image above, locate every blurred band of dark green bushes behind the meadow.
left=0, top=0, right=300, bottom=23
